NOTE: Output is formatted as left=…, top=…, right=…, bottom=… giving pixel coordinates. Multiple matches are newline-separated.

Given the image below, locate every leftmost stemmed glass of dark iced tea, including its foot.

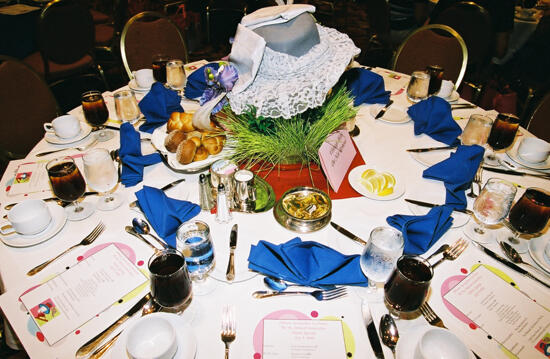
left=46, top=157, right=94, bottom=221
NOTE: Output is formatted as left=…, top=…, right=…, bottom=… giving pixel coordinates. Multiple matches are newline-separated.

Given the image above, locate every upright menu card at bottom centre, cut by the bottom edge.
left=262, top=319, right=346, bottom=359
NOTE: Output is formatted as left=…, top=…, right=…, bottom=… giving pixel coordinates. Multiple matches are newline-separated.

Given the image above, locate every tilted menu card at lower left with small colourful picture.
left=20, top=244, right=148, bottom=345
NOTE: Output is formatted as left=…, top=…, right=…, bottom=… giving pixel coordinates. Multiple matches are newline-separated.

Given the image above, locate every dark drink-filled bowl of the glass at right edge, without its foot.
left=509, top=188, right=550, bottom=234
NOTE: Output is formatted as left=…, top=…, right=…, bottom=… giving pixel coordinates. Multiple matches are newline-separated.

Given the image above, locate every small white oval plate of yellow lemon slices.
left=348, top=165, right=405, bottom=201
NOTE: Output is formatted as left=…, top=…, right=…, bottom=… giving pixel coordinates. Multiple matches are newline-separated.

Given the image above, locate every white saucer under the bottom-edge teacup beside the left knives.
left=111, top=313, right=197, bottom=359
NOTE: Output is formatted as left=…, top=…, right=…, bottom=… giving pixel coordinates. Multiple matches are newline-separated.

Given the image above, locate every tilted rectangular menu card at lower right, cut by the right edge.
left=444, top=266, right=550, bottom=359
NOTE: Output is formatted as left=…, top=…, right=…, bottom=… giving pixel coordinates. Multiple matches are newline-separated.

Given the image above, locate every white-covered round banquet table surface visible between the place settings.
left=0, top=68, right=550, bottom=359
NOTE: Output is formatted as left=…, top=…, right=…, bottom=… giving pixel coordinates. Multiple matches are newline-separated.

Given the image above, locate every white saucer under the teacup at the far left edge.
left=0, top=203, right=67, bottom=247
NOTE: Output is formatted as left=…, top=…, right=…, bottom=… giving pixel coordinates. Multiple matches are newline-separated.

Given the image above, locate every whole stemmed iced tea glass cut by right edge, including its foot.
left=508, top=187, right=550, bottom=253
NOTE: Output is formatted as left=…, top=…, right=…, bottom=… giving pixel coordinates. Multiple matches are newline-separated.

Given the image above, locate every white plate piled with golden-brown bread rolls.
left=151, top=112, right=229, bottom=173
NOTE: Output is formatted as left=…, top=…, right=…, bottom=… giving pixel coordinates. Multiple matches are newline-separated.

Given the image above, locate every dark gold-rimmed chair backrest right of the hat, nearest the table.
left=392, top=25, right=468, bottom=88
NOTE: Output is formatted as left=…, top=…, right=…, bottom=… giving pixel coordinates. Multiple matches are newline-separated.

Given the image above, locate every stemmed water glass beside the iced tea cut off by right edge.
left=464, top=178, right=517, bottom=243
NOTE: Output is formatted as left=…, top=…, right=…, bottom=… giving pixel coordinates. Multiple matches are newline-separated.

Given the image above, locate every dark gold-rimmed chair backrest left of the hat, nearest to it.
left=120, top=11, right=189, bottom=78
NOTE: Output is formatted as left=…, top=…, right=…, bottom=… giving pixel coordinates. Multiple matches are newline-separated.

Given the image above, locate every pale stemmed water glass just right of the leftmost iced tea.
left=82, top=148, right=122, bottom=211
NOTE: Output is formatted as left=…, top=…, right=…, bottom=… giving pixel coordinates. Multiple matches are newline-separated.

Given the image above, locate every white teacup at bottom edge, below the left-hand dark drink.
left=126, top=314, right=178, bottom=359
